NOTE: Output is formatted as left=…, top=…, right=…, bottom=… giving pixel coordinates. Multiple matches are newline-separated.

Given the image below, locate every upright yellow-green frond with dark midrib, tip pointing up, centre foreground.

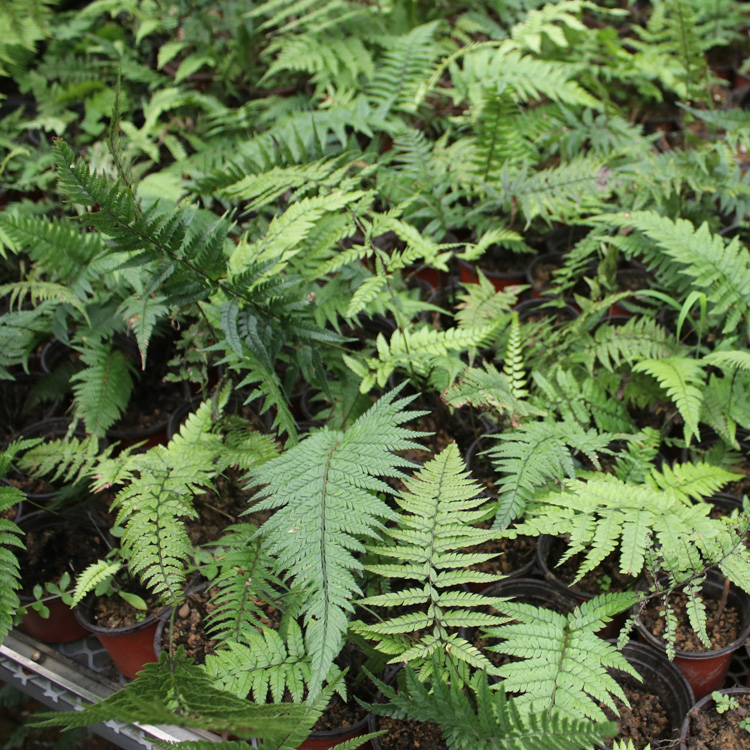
left=357, top=443, right=502, bottom=679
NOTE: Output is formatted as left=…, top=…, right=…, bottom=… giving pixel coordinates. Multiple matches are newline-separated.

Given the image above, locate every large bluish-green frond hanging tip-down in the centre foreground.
left=250, top=390, right=423, bottom=696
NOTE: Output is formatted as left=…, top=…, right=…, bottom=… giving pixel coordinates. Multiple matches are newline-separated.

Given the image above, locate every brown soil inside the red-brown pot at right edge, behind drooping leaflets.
left=641, top=591, right=741, bottom=651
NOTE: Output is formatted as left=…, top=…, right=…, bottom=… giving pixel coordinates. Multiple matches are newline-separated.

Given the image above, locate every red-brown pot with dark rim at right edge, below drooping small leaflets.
left=636, top=570, right=750, bottom=700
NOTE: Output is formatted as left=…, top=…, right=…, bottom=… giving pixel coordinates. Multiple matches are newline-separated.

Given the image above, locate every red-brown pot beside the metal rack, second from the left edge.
left=75, top=596, right=169, bottom=680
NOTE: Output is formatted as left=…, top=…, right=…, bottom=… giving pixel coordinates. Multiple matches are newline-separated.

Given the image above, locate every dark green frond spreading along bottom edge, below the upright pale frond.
left=369, top=663, right=616, bottom=750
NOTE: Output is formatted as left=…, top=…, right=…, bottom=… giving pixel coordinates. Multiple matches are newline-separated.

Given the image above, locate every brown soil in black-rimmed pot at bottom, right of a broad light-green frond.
left=600, top=680, right=675, bottom=748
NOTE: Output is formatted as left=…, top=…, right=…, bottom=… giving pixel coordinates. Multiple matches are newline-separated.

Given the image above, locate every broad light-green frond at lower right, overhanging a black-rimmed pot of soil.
left=484, top=593, right=639, bottom=721
